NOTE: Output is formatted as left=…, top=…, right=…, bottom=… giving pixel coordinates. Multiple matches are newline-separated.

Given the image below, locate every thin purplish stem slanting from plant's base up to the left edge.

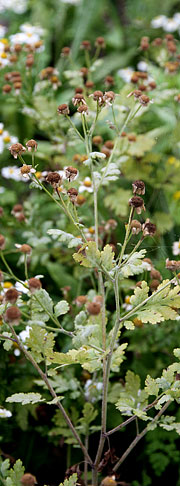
left=9, top=324, right=92, bottom=465
